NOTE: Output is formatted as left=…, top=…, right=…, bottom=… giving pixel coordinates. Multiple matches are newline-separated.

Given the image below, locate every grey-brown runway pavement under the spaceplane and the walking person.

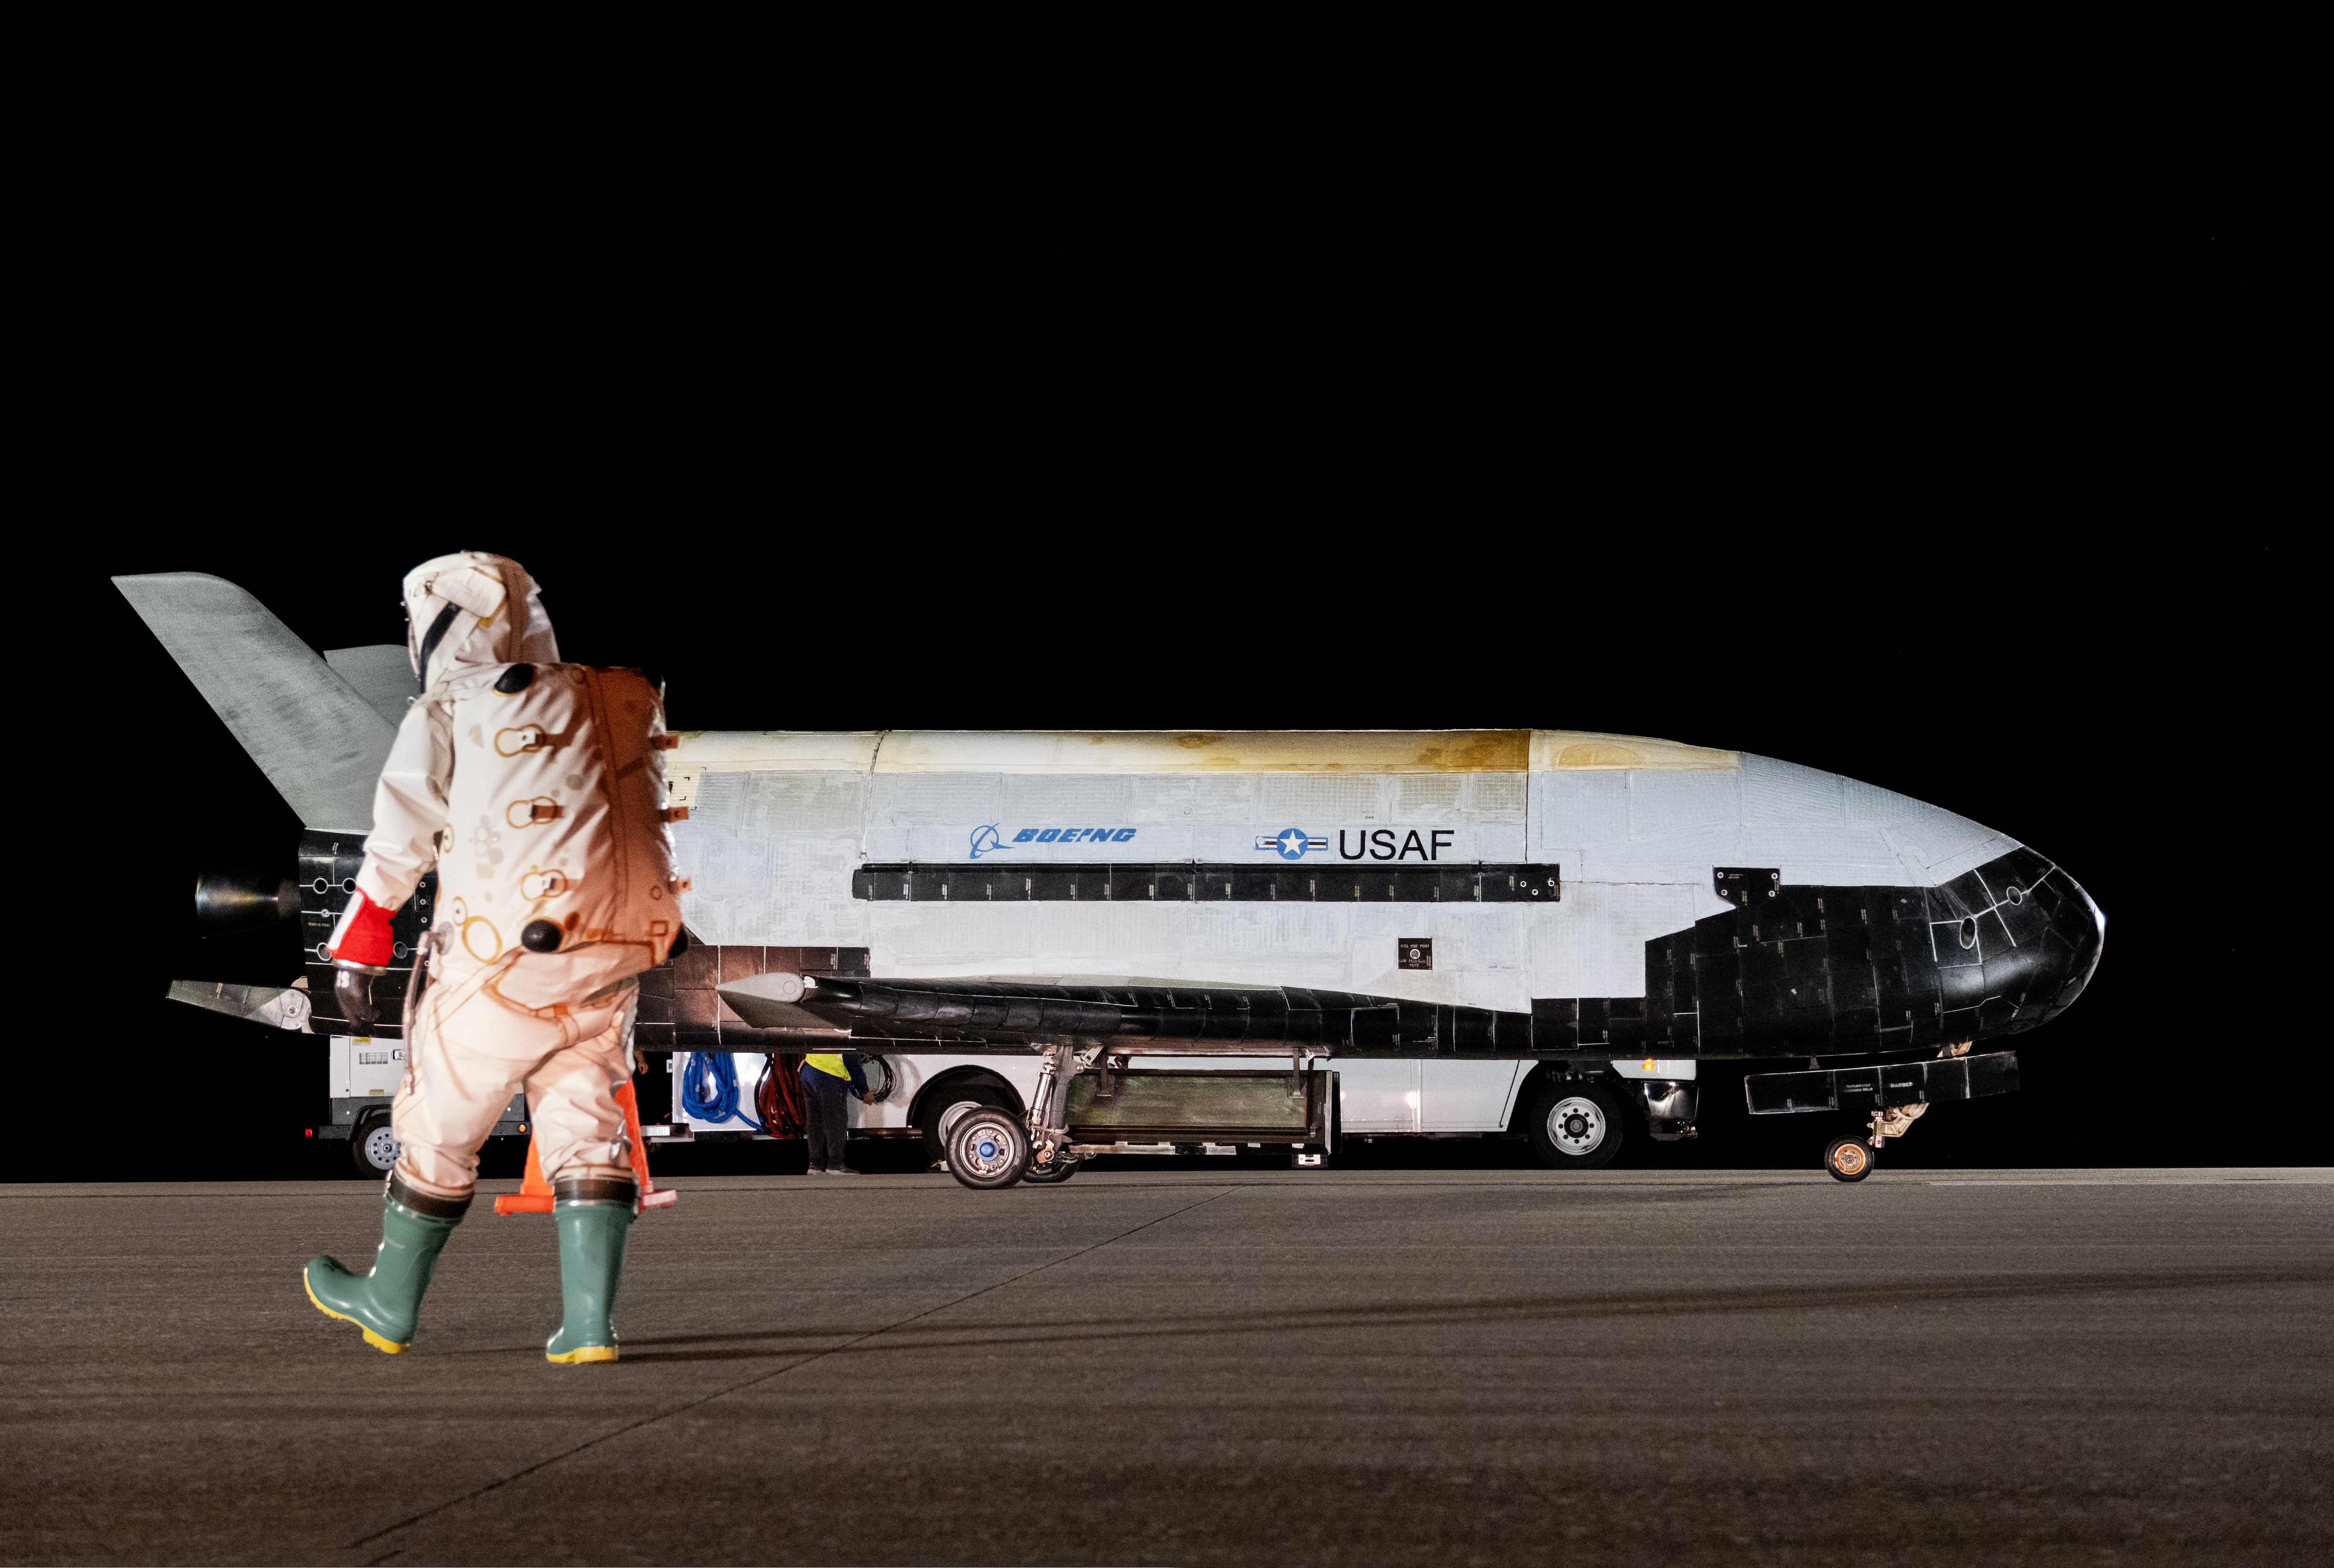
left=0, top=1164, right=2334, bottom=1568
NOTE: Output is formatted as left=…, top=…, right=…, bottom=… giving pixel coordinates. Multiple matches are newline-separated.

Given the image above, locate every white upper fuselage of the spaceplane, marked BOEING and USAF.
left=670, top=731, right=2014, bottom=1010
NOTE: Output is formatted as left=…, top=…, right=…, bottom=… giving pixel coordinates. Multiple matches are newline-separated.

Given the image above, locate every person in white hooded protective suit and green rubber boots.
left=306, top=551, right=686, bottom=1365
